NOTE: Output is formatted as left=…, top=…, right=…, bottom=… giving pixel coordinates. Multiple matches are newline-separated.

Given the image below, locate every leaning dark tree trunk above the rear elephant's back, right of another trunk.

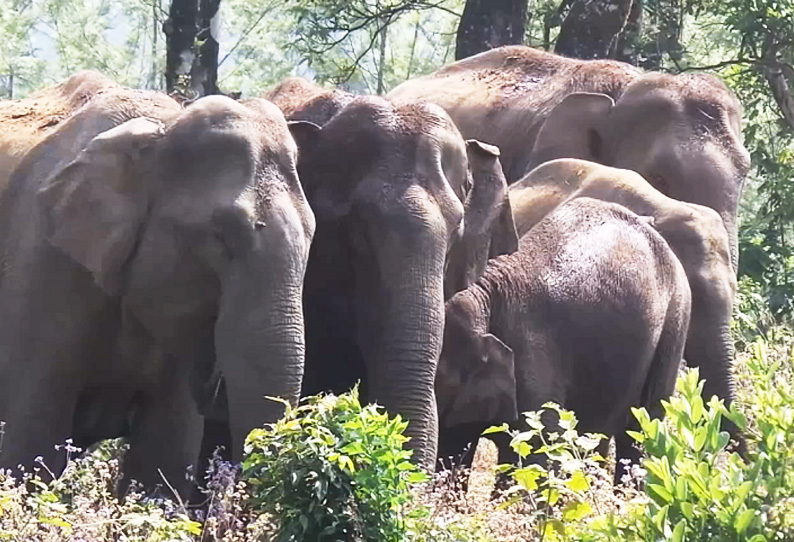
left=554, top=0, right=633, bottom=59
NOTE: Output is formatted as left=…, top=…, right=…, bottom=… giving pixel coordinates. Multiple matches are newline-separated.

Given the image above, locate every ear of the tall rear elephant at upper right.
left=527, top=92, right=615, bottom=171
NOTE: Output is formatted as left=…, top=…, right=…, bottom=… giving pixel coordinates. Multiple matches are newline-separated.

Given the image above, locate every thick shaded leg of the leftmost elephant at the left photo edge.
left=0, top=270, right=118, bottom=475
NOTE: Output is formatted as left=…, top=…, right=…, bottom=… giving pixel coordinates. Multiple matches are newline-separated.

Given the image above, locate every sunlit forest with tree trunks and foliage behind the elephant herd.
left=0, top=0, right=794, bottom=338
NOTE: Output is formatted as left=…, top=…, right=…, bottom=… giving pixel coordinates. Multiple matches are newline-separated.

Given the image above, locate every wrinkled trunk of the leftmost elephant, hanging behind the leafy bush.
left=215, top=240, right=306, bottom=461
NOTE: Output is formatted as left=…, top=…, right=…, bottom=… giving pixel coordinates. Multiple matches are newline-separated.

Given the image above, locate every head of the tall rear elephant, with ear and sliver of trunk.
left=526, top=74, right=750, bottom=268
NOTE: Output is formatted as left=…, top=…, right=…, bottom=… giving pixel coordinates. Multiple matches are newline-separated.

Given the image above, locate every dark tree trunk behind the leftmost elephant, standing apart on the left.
left=163, top=0, right=220, bottom=98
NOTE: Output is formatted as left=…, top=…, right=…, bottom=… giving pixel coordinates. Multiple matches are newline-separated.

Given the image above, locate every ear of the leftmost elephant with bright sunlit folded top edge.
left=37, top=117, right=164, bottom=295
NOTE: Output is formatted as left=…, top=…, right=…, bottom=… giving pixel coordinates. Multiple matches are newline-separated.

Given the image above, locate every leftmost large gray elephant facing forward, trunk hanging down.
left=0, top=89, right=314, bottom=496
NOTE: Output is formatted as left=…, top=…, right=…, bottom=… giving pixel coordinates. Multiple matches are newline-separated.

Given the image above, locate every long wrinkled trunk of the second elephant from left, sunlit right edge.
left=358, top=225, right=446, bottom=472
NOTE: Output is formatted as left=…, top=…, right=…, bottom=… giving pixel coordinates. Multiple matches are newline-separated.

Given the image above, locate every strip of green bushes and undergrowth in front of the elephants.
left=0, top=333, right=794, bottom=542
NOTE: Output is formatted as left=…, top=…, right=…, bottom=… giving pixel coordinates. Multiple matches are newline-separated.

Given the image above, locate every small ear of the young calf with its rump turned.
left=444, top=333, right=518, bottom=427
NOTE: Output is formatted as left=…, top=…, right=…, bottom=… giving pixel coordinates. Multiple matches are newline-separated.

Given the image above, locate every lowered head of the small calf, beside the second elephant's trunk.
left=436, top=288, right=518, bottom=429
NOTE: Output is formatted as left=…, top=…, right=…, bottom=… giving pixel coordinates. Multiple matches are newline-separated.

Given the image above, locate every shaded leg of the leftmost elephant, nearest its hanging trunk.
left=123, top=367, right=204, bottom=498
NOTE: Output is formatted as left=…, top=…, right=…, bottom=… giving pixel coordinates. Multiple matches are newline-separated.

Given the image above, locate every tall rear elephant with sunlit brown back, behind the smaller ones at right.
left=388, top=46, right=750, bottom=269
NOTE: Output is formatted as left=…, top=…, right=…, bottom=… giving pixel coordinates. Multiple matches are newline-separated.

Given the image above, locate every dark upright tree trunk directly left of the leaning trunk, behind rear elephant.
left=455, top=0, right=528, bottom=60
